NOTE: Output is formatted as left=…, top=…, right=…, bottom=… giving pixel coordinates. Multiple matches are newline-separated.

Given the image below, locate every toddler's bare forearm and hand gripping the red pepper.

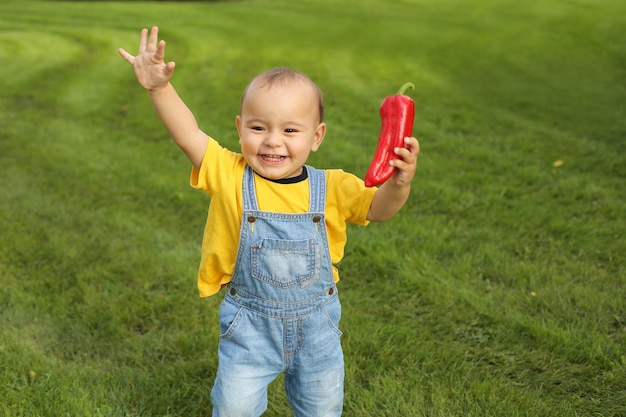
left=367, top=138, right=420, bottom=222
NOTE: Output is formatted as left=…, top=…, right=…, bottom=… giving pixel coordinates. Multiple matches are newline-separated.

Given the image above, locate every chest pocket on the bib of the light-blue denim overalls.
left=251, top=239, right=322, bottom=288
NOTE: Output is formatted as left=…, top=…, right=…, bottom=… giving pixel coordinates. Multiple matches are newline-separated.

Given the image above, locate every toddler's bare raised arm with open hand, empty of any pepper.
left=119, top=26, right=209, bottom=168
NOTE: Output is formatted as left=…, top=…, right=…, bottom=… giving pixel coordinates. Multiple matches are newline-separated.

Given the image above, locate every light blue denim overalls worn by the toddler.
left=211, top=166, right=344, bottom=417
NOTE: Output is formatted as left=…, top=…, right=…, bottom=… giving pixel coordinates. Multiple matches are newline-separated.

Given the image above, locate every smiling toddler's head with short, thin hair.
left=236, top=82, right=326, bottom=179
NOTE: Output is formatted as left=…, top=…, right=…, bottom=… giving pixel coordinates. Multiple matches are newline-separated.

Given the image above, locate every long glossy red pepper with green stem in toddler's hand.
left=365, top=83, right=415, bottom=187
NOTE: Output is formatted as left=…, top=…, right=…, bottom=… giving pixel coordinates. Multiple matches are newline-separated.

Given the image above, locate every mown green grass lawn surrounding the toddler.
left=0, top=0, right=626, bottom=417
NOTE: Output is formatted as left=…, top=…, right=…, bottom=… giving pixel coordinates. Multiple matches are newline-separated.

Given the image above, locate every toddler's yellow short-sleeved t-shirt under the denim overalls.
left=190, top=138, right=376, bottom=297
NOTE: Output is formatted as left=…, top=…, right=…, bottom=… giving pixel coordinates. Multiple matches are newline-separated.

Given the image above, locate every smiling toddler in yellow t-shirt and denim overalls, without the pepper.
left=119, top=27, right=419, bottom=417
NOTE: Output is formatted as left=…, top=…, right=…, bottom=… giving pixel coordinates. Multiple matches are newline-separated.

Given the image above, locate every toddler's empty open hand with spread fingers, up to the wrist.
left=118, top=26, right=176, bottom=91
